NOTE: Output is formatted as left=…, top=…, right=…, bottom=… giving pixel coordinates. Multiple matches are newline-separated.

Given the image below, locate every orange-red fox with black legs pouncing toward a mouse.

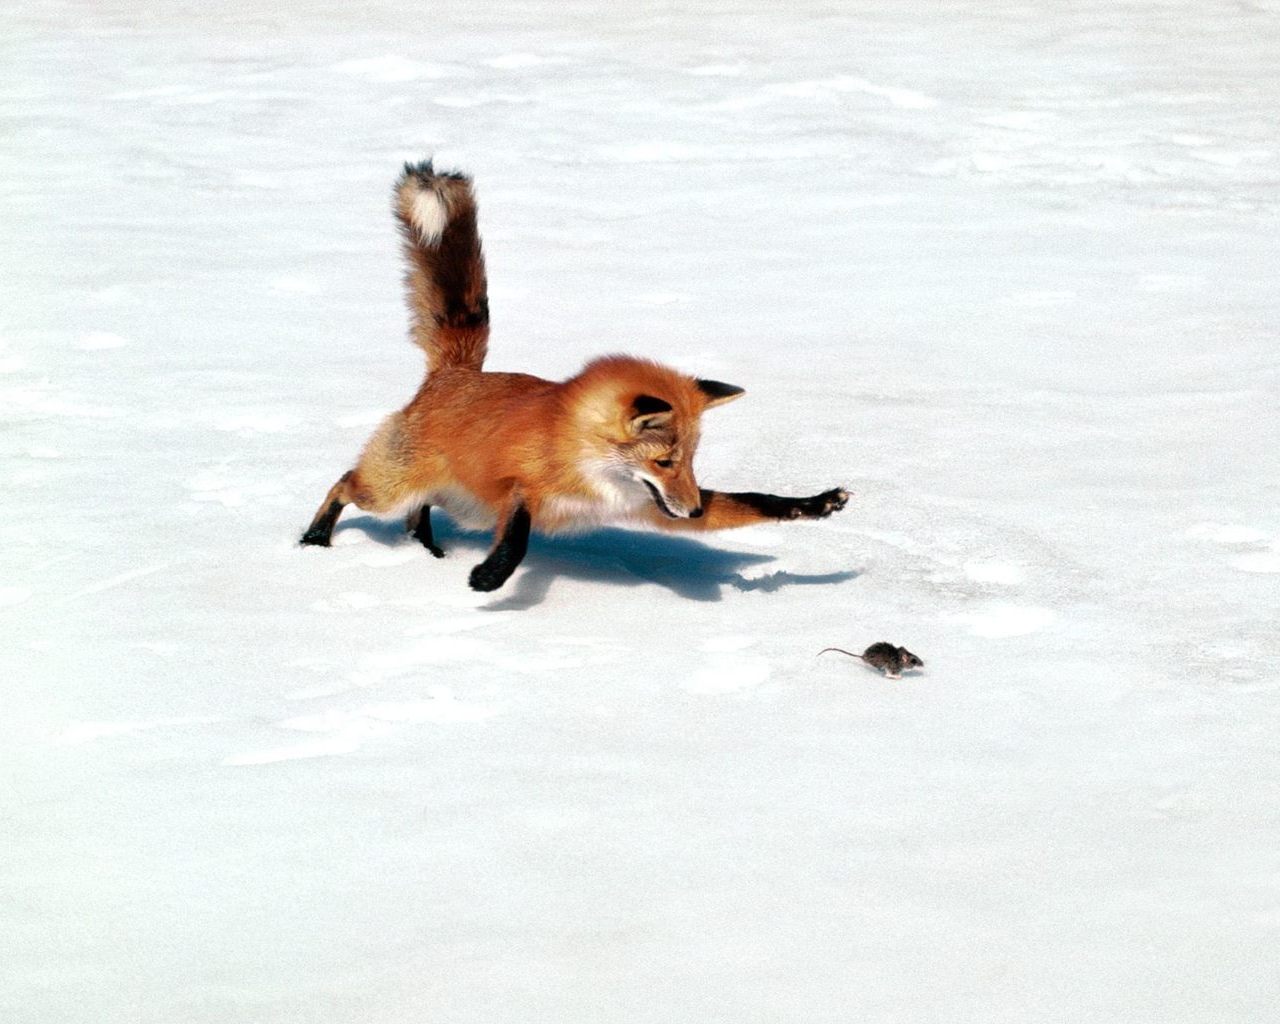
left=302, top=160, right=849, bottom=590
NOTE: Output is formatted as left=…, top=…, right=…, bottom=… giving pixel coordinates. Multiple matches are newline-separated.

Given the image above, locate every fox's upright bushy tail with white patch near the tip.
left=396, top=160, right=489, bottom=371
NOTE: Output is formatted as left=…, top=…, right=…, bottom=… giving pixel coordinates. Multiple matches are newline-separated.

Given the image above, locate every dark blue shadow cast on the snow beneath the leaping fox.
left=337, top=509, right=859, bottom=611
